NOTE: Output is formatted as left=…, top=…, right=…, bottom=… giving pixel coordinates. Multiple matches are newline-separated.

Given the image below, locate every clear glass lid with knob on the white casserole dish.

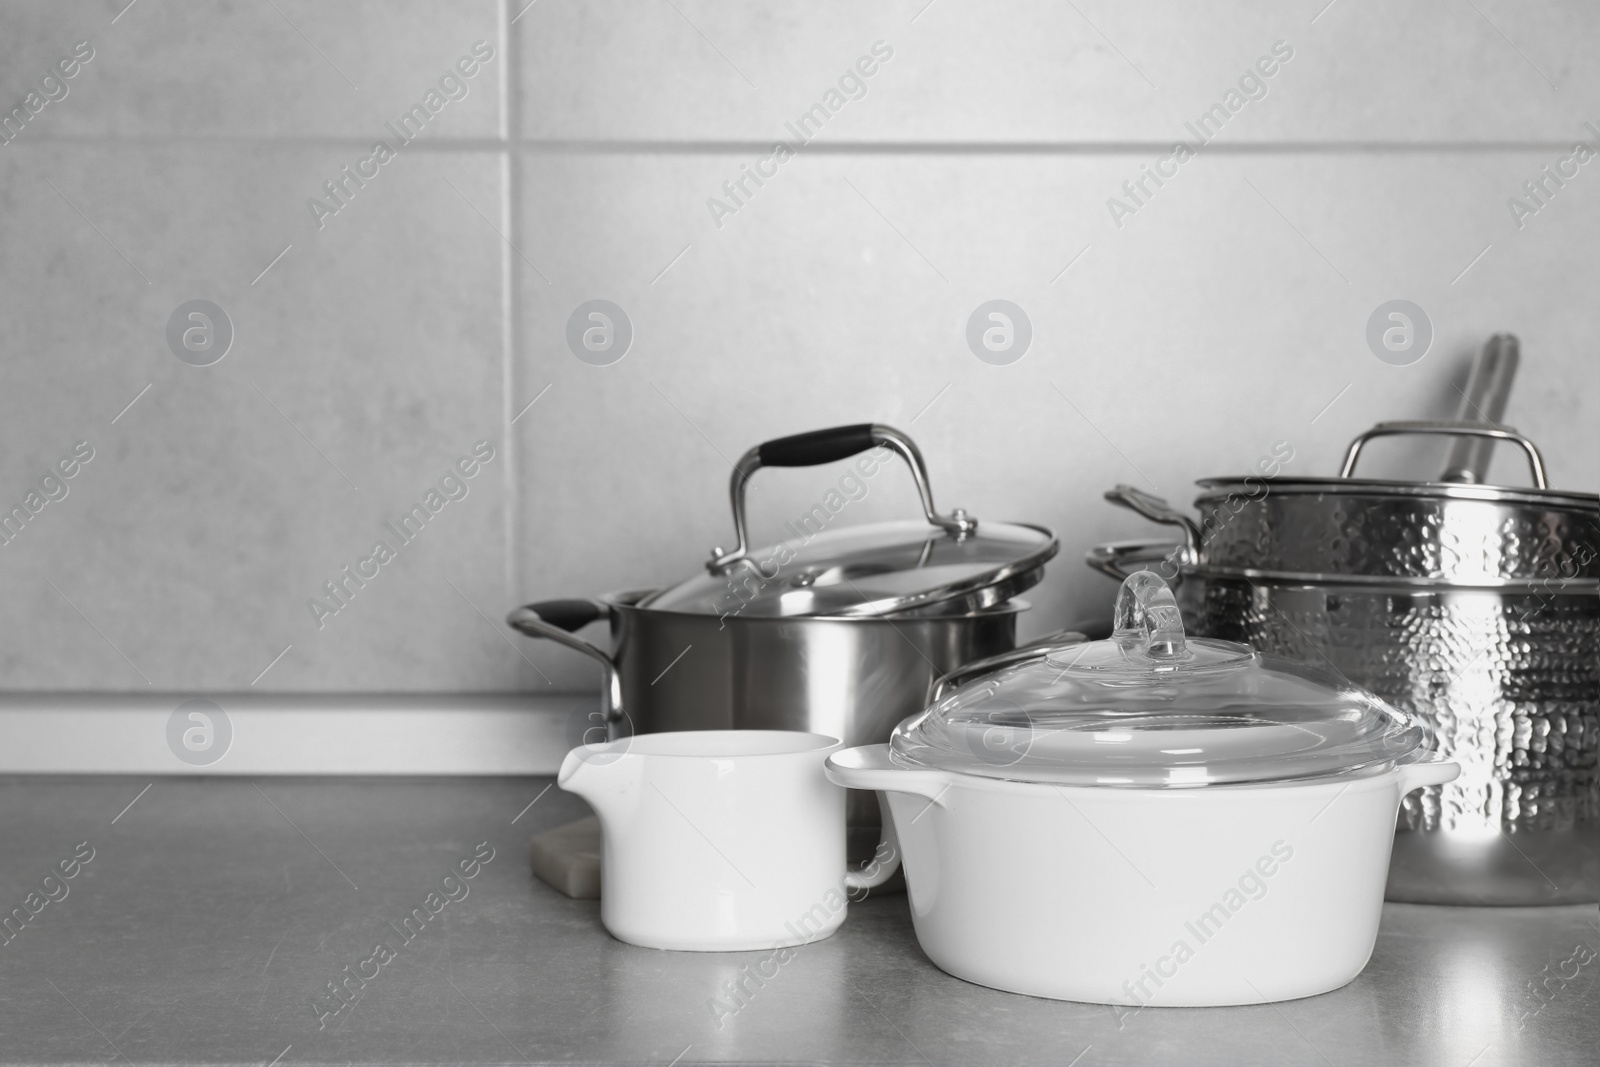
left=890, top=571, right=1427, bottom=789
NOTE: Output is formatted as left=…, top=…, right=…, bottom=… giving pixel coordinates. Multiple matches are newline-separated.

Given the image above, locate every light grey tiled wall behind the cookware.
left=0, top=0, right=1600, bottom=691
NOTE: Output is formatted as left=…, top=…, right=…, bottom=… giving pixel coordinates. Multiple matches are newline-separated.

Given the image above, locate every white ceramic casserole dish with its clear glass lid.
left=827, top=571, right=1459, bottom=1011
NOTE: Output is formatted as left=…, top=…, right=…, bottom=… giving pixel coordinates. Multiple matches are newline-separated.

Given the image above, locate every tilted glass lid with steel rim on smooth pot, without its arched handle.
left=640, top=514, right=1058, bottom=617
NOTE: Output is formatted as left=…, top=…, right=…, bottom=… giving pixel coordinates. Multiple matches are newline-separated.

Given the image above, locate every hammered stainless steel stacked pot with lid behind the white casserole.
left=1088, top=422, right=1600, bottom=904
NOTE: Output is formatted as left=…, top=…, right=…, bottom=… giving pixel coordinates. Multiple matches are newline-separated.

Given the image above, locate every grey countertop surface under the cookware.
left=0, top=777, right=1600, bottom=1067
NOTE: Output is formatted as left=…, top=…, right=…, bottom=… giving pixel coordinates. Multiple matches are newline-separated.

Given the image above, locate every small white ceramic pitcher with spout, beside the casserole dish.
left=557, top=729, right=898, bottom=952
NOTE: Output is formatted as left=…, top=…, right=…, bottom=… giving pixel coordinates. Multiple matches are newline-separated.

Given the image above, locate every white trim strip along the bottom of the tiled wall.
left=0, top=693, right=586, bottom=774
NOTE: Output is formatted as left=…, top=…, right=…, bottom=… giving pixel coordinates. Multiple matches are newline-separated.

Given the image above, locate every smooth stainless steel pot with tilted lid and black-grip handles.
left=507, top=424, right=1061, bottom=843
